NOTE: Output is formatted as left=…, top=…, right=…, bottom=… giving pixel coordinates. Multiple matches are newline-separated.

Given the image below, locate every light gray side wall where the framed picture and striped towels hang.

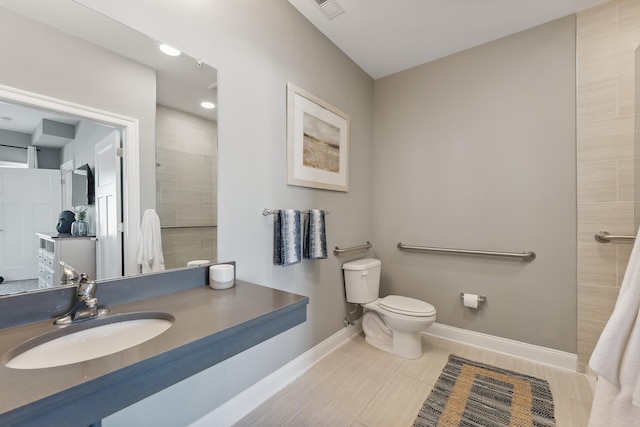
left=76, top=0, right=373, bottom=427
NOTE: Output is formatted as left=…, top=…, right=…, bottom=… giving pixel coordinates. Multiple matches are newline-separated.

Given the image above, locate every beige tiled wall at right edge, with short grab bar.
left=577, top=0, right=640, bottom=371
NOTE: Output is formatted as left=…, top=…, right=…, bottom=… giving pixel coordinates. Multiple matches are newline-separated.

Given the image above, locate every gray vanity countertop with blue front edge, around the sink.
left=0, top=280, right=309, bottom=426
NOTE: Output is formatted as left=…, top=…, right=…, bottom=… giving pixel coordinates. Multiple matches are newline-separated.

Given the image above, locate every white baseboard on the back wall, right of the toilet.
left=423, top=323, right=578, bottom=372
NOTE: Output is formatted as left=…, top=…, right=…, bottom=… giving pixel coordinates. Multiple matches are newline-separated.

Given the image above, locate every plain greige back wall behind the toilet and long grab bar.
left=373, top=16, right=576, bottom=353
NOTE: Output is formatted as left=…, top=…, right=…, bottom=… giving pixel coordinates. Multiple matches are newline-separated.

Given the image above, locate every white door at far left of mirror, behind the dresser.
left=0, top=169, right=62, bottom=280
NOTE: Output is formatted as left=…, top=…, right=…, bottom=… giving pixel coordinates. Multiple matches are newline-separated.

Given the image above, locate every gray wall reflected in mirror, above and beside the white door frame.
left=0, top=9, right=156, bottom=212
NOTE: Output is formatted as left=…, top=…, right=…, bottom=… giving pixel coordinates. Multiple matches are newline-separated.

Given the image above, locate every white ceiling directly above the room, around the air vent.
left=289, top=0, right=608, bottom=79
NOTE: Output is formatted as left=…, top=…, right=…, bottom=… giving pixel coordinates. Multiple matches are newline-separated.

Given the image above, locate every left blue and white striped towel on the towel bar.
left=273, top=209, right=302, bottom=266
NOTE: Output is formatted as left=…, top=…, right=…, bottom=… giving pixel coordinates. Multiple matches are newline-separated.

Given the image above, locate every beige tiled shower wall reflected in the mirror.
left=156, top=105, right=218, bottom=269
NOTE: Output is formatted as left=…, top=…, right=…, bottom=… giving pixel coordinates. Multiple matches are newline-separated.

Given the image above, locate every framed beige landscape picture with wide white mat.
left=287, top=83, right=349, bottom=191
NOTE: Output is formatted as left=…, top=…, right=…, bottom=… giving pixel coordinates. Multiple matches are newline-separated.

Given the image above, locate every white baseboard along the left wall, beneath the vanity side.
left=189, top=319, right=362, bottom=427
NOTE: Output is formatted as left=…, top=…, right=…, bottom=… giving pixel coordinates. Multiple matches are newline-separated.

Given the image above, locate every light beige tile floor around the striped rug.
left=235, top=335, right=592, bottom=427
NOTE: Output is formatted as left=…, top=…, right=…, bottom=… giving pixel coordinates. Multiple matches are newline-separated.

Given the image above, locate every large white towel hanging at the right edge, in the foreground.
left=589, top=226, right=640, bottom=427
